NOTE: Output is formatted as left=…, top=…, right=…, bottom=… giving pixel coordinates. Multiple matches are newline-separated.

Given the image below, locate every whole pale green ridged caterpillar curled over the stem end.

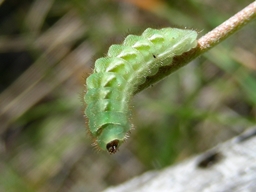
left=84, top=28, right=197, bottom=153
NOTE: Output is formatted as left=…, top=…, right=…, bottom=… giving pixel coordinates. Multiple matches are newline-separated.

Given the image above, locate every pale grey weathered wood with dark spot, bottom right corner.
left=104, top=127, right=256, bottom=192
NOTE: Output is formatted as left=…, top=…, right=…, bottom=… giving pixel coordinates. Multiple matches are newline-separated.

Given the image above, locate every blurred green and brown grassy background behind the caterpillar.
left=0, top=0, right=256, bottom=192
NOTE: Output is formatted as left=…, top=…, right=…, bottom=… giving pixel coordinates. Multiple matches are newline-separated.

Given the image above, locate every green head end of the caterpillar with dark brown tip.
left=96, top=124, right=127, bottom=154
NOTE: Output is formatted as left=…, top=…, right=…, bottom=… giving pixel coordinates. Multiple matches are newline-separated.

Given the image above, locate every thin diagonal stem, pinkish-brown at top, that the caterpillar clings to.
left=135, top=1, right=256, bottom=94
